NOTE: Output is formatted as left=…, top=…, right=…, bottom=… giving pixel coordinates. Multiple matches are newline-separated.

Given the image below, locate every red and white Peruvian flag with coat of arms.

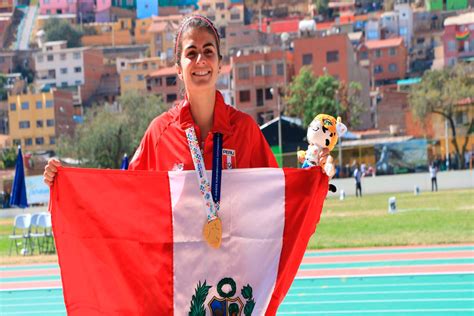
left=50, top=167, right=328, bottom=316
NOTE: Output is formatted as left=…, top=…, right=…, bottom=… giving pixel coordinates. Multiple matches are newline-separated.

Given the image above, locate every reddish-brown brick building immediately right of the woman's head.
left=231, top=51, right=293, bottom=125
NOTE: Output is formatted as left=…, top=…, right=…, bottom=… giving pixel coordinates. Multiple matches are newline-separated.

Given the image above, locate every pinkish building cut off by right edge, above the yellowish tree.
left=442, top=12, right=474, bottom=66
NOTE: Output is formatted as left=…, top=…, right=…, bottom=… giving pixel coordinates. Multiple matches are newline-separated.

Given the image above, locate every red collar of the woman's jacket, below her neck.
left=177, top=91, right=232, bottom=135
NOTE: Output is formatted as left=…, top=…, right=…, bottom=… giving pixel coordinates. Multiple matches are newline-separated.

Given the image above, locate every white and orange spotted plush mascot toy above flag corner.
left=298, top=114, right=347, bottom=192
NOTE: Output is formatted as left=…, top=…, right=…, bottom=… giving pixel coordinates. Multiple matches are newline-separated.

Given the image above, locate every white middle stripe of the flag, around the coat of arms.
left=169, top=168, right=285, bottom=315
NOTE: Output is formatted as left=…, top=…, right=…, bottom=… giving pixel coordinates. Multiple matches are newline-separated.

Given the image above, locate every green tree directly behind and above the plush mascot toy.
left=286, top=67, right=362, bottom=126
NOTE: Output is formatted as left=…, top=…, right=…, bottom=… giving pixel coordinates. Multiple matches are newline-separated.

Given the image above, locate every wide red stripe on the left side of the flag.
left=51, top=168, right=173, bottom=316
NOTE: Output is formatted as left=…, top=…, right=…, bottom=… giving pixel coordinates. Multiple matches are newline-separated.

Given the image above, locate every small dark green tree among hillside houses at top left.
left=43, top=18, right=83, bottom=48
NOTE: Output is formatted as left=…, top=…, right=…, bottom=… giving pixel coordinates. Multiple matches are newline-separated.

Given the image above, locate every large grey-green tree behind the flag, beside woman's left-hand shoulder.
left=58, top=92, right=167, bottom=169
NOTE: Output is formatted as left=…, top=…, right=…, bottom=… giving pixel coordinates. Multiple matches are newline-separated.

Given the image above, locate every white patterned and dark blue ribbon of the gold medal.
left=185, top=127, right=222, bottom=222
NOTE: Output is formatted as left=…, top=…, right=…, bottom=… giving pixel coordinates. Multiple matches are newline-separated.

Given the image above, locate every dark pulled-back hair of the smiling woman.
left=174, top=15, right=222, bottom=65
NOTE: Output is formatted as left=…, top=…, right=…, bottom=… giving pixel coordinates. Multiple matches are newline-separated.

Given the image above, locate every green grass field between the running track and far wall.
left=0, top=190, right=474, bottom=261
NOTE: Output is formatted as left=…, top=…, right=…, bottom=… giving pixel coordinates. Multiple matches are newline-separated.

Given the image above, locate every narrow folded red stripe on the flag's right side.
left=266, top=167, right=328, bottom=315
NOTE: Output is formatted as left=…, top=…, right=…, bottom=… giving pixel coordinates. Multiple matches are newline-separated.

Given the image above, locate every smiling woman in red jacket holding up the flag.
left=44, top=15, right=328, bottom=186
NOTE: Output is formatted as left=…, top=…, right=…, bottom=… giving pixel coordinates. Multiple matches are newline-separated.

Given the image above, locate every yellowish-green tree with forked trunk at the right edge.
left=408, top=64, right=474, bottom=169
